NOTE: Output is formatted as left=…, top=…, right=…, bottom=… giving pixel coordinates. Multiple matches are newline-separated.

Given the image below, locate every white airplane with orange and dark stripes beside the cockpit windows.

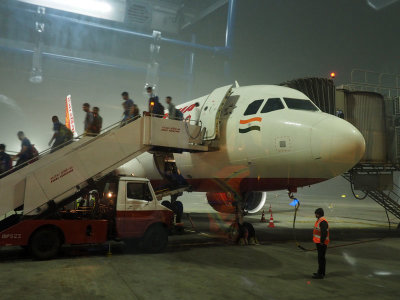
left=66, top=82, right=365, bottom=240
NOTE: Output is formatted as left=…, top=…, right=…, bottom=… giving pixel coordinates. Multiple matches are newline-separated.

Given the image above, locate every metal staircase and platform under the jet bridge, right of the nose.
left=342, top=163, right=400, bottom=228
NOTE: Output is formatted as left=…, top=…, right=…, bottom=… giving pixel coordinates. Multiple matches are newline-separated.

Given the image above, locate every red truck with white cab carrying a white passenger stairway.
left=0, top=116, right=207, bottom=259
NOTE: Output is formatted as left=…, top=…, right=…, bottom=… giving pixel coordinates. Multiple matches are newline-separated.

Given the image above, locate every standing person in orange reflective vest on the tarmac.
left=313, top=208, right=329, bottom=279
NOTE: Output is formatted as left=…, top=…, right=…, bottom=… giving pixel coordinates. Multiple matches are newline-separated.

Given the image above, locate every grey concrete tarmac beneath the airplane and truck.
left=0, top=177, right=400, bottom=300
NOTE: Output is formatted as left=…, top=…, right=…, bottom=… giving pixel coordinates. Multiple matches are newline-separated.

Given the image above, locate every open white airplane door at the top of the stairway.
left=200, top=85, right=233, bottom=140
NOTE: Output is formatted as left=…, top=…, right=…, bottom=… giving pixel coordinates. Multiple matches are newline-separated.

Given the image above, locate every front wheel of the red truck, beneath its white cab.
left=140, top=224, right=168, bottom=253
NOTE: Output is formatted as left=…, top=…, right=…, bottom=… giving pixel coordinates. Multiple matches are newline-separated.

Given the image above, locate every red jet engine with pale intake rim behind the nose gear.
left=207, top=192, right=267, bottom=214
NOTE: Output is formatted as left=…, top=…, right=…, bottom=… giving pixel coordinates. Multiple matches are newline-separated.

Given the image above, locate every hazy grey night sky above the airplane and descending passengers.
left=0, top=0, right=400, bottom=151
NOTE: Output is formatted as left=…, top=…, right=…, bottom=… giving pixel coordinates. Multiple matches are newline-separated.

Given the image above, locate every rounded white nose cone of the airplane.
left=311, top=116, right=365, bottom=176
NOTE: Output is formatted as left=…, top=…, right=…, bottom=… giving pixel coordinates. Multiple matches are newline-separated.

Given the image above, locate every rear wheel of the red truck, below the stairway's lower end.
left=29, top=228, right=61, bottom=260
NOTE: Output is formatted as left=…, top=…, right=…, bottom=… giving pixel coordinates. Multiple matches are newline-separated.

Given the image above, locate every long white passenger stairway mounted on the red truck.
left=0, top=116, right=208, bottom=215
